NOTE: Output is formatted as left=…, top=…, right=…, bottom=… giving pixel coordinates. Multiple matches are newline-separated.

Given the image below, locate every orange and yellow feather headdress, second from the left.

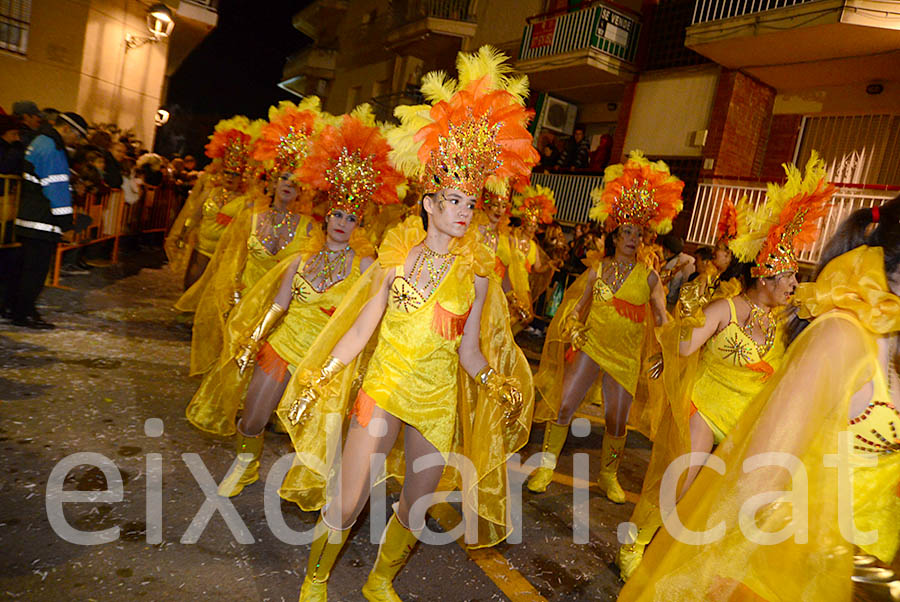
left=253, top=96, right=335, bottom=177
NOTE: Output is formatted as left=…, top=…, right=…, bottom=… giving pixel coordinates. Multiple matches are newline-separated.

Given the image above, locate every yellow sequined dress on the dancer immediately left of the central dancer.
left=267, top=256, right=360, bottom=366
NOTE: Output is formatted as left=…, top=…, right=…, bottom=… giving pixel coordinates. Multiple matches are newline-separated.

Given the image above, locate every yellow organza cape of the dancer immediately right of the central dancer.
left=534, top=252, right=664, bottom=440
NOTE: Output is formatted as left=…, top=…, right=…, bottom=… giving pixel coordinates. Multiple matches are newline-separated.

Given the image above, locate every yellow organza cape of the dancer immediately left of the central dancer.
left=185, top=227, right=375, bottom=437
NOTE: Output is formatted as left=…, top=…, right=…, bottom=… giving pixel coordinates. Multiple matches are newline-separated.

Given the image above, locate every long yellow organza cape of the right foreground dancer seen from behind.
left=619, top=247, right=900, bottom=602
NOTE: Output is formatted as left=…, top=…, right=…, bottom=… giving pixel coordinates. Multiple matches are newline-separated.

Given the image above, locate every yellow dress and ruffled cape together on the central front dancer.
left=277, top=217, right=534, bottom=546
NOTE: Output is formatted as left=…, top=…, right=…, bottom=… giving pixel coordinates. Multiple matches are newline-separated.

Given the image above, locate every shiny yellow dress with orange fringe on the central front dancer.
left=362, top=257, right=475, bottom=453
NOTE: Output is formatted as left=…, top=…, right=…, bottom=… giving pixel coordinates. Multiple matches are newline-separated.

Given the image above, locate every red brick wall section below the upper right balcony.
left=701, top=69, right=775, bottom=177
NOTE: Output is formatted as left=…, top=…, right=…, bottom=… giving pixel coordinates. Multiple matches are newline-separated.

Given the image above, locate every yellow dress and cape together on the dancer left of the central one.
left=185, top=228, right=374, bottom=436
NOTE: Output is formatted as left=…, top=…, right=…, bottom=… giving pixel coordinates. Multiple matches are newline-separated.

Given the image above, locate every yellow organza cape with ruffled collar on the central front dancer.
left=277, top=216, right=534, bottom=547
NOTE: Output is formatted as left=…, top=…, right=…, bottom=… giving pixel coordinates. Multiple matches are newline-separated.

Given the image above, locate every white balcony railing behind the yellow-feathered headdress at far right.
left=686, top=180, right=897, bottom=264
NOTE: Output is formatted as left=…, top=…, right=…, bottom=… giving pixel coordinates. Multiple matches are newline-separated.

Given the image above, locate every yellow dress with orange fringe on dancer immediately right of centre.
left=581, top=263, right=650, bottom=395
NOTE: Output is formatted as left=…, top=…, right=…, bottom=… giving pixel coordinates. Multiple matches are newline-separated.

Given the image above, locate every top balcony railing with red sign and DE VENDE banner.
left=519, top=2, right=640, bottom=62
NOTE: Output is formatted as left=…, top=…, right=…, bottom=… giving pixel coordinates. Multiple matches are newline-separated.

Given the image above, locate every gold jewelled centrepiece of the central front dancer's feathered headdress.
left=423, top=109, right=502, bottom=196
